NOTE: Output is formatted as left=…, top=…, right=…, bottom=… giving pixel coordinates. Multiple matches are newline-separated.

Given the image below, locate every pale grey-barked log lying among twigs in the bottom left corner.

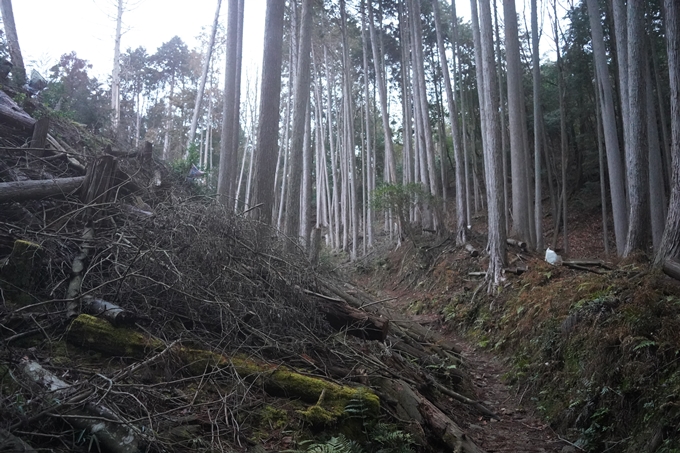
left=19, top=358, right=139, bottom=453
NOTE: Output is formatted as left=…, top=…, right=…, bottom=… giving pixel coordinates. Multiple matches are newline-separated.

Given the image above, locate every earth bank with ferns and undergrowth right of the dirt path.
left=442, top=262, right=680, bottom=453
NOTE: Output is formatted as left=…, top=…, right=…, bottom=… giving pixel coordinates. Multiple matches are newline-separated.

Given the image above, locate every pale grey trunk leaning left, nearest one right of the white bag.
left=587, top=0, right=628, bottom=255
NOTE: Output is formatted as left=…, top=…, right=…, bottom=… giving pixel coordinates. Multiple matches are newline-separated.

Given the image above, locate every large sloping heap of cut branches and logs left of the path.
left=0, top=88, right=494, bottom=453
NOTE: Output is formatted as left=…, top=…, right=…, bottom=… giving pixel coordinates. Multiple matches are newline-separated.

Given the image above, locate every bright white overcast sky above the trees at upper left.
left=12, top=0, right=266, bottom=82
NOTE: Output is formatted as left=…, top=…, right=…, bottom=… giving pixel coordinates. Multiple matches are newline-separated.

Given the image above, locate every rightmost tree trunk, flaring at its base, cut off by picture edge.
left=654, top=0, right=680, bottom=267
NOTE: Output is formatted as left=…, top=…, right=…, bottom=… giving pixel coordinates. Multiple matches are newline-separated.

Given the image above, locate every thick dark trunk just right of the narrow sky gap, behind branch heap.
left=253, top=0, right=285, bottom=231
